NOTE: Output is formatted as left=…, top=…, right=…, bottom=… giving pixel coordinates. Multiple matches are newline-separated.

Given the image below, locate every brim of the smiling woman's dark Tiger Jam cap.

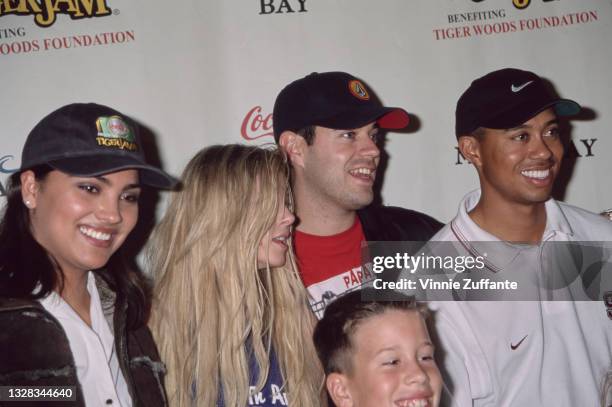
left=48, top=155, right=178, bottom=189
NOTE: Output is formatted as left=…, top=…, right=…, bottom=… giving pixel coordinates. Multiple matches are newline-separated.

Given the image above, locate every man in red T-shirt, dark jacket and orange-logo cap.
left=273, top=72, right=441, bottom=317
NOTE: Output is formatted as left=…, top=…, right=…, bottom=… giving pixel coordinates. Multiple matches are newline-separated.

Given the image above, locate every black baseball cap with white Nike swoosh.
left=455, top=68, right=581, bottom=138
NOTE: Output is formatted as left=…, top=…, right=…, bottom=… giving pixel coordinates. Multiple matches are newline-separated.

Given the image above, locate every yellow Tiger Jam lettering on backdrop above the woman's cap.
left=0, top=0, right=113, bottom=27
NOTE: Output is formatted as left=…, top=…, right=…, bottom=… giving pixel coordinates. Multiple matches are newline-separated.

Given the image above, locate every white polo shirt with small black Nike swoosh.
left=430, top=190, right=612, bottom=407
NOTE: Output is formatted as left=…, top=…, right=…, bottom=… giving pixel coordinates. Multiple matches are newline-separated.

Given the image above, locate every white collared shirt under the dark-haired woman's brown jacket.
left=40, top=271, right=132, bottom=407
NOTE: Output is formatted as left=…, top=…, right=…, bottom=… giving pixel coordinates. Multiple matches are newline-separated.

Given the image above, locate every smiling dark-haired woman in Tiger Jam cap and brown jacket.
left=0, top=104, right=175, bottom=406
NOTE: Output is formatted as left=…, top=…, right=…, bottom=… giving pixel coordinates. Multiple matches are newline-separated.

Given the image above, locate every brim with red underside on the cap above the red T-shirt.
left=314, top=106, right=410, bottom=130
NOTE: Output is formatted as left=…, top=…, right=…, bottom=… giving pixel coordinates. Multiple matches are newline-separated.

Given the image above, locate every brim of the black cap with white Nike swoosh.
left=482, top=99, right=582, bottom=129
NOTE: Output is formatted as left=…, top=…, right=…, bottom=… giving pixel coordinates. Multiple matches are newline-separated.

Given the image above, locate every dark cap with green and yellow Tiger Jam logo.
left=19, top=103, right=177, bottom=188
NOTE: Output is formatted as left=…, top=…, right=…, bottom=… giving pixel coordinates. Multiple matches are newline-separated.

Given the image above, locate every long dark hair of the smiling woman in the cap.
left=0, top=165, right=149, bottom=328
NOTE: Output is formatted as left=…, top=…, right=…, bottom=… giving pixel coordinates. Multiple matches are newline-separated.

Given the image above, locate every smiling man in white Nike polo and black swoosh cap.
left=430, top=69, right=612, bottom=407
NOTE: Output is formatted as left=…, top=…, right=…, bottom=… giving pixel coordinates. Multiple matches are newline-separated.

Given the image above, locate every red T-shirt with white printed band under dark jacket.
left=294, top=217, right=373, bottom=319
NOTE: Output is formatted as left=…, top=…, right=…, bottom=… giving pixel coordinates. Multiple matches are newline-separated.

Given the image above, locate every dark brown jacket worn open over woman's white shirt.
left=0, top=277, right=167, bottom=407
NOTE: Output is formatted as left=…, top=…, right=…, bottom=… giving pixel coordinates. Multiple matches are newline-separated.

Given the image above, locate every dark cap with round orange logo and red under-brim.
left=272, top=72, right=410, bottom=143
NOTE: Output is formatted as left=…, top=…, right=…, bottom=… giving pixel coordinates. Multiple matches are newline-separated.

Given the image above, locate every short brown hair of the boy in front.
left=313, top=288, right=427, bottom=375
